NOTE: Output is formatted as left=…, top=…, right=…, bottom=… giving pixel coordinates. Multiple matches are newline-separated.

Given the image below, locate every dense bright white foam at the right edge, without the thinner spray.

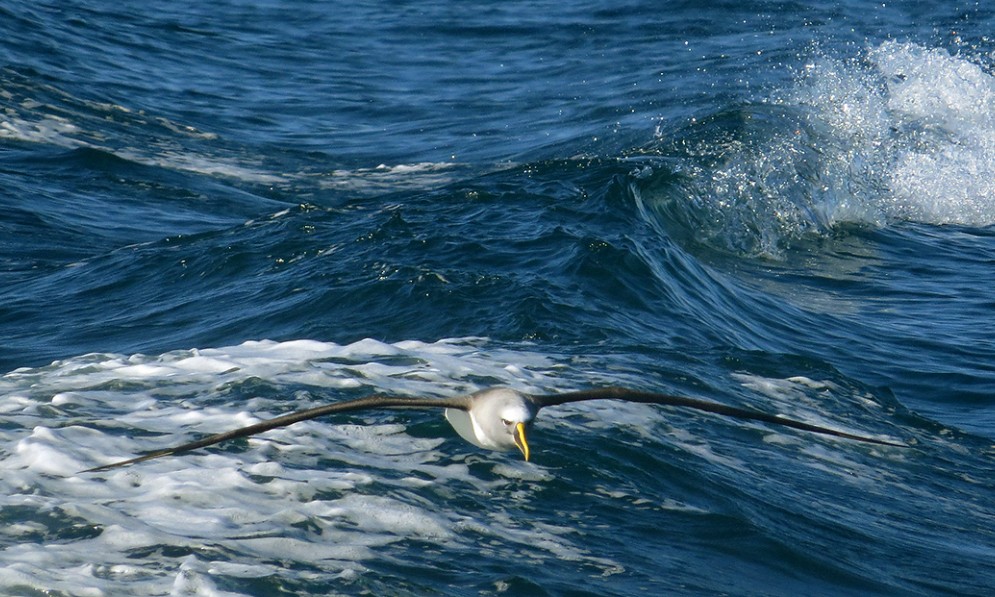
left=786, top=41, right=995, bottom=226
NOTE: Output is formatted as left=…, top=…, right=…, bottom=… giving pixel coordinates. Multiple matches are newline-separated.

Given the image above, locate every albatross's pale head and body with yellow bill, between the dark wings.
left=446, top=388, right=538, bottom=460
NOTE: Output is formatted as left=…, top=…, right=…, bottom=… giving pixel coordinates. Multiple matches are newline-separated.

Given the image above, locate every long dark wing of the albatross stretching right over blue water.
left=529, top=388, right=908, bottom=448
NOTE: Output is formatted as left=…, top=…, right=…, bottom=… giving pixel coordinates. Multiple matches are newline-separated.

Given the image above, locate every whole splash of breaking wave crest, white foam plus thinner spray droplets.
left=633, top=41, right=995, bottom=258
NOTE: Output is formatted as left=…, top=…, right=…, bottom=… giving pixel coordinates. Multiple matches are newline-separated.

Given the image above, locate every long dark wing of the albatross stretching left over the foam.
left=80, top=394, right=470, bottom=473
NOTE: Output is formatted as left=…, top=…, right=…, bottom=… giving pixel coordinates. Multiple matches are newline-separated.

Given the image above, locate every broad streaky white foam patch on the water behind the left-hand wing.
left=0, top=338, right=632, bottom=595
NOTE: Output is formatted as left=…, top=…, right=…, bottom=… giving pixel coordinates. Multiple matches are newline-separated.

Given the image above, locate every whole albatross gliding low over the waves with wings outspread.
left=82, top=387, right=907, bottom=473
